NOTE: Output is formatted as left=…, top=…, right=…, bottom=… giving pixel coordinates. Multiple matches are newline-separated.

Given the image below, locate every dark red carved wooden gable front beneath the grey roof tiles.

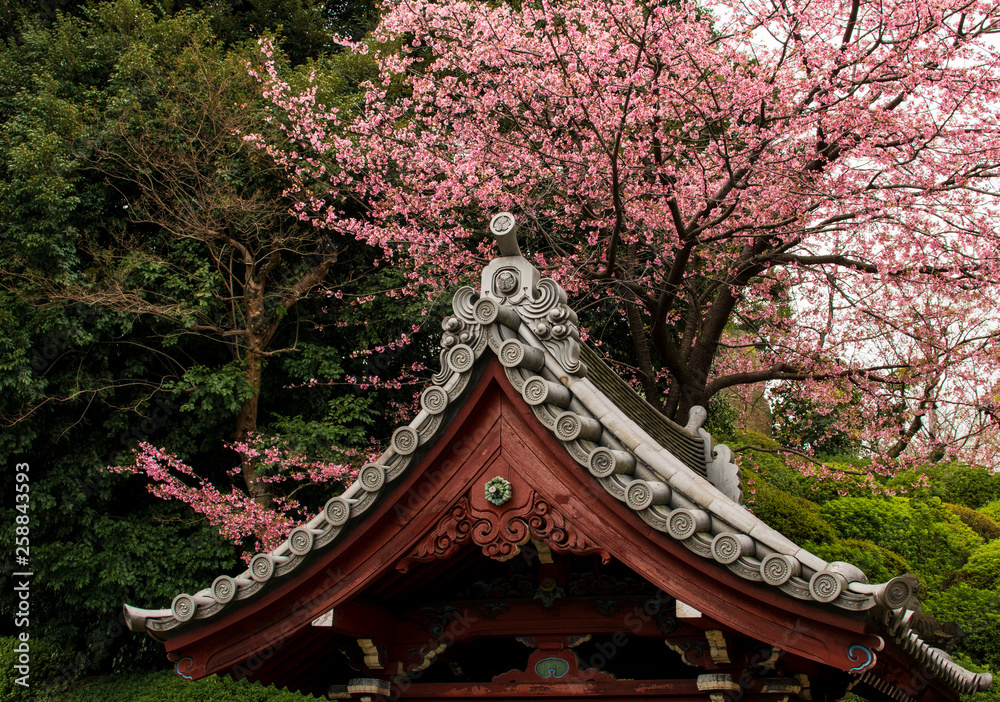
left=154, top=360, right=879, bottom=700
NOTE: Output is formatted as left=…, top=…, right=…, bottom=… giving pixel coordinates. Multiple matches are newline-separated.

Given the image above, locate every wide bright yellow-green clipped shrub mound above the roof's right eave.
left=820, top=497, right=983, bottom=589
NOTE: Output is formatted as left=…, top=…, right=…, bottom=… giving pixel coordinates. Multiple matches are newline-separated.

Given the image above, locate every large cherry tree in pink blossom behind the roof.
left=248, top=0, right=1000, bottom=466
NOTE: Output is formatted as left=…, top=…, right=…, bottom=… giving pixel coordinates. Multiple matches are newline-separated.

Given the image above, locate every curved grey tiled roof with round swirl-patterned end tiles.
left=125, top=214, right=992, bottom=699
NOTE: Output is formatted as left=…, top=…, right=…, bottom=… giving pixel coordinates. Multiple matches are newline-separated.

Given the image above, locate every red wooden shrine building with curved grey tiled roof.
left=125, top=214, right=992, bottom=702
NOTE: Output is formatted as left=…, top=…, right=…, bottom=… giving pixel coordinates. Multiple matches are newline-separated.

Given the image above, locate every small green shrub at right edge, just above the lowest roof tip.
left=924, top=583, right=1000, bottom=670
